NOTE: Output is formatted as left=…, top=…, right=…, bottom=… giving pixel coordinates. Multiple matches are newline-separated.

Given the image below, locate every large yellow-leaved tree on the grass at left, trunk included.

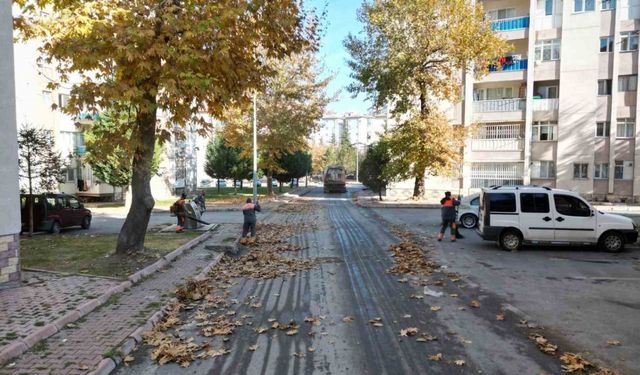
left=14, top=0, right=316, bottom=253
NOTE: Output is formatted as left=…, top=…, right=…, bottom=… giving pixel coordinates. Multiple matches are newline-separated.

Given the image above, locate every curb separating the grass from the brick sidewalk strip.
left=0, top=225, right=217, bottom=368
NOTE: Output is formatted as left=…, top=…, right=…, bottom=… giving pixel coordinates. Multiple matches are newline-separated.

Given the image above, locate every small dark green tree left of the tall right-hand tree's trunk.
left=360, top=138, right=391, bottom=200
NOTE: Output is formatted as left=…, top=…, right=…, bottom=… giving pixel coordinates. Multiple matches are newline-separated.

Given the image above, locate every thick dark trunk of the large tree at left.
left=116, top=103, right=156, bottom=254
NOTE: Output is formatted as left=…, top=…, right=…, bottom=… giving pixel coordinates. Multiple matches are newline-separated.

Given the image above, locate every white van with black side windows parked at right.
left=477, top=186, right=638, bottom=252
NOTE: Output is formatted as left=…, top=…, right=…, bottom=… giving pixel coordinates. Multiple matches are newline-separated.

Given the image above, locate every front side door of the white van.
left=553, top=193, right=596, bottom=243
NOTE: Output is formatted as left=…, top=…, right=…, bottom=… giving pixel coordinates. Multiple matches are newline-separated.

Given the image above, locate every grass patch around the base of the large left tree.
left=20, top=232, right=201, bottom=277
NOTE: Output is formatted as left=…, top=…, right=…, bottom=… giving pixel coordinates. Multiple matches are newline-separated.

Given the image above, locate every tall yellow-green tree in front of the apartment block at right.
left=345, top=0, right=509, bottom=197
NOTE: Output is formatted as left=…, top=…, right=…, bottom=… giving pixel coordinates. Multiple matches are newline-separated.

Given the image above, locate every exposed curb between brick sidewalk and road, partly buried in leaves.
left=89, top=253, right=224, bottom=375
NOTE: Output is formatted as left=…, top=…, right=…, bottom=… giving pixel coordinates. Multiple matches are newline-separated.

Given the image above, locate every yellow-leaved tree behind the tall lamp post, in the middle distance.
left=224, top=50, right=330, bottom=195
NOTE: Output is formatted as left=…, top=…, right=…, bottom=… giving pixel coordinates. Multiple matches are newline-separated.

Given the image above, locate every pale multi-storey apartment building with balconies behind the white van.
left=449, top=0, right=640, bottom=201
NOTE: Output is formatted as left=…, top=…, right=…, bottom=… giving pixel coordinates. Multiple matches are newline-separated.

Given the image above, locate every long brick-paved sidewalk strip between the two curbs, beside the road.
left=0, top=225, right=237, bottom=375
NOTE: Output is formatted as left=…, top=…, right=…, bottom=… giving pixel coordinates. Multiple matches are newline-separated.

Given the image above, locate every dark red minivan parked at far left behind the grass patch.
left=20, top=193, right=91, bottom=234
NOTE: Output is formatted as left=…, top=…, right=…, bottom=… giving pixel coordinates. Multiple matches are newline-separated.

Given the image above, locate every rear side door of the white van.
left=520, top=192, right=556, bottom=242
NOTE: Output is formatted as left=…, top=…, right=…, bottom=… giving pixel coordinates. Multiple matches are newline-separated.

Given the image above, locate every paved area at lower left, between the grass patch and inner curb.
left=0, top=271, right=120, bottom=351
